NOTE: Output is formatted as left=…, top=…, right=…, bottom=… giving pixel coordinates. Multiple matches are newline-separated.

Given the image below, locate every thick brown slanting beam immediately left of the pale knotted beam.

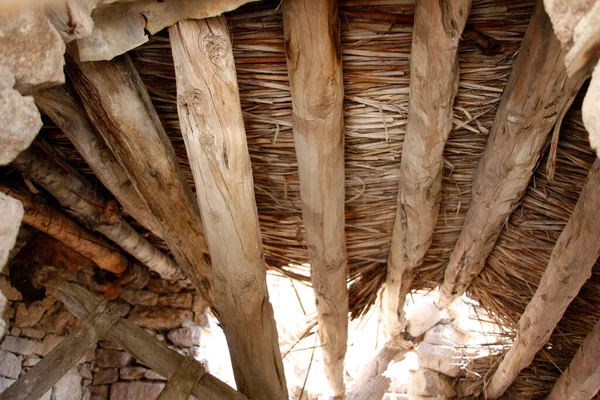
left=67, top=51, right=214, bottom=306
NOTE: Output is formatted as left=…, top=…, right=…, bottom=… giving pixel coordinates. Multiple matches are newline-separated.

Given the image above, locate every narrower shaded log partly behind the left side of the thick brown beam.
left=34, top=84, right=161, bottom=237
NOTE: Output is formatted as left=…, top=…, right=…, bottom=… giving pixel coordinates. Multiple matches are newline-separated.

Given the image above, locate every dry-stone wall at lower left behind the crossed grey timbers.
left=0, top=242, right=208, bottom=400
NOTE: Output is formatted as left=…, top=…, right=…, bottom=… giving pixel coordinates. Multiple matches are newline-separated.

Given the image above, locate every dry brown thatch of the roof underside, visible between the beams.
left=37, top=0, right=600, bottom=398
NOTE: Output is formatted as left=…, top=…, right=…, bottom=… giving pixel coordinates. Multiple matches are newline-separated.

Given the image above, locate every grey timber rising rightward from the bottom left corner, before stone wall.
left=0, top=301, right=120, bottom=400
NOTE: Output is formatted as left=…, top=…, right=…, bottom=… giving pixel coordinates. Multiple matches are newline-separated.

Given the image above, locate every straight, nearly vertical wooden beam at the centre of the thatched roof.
left=282, top=0, right=348, bottom=397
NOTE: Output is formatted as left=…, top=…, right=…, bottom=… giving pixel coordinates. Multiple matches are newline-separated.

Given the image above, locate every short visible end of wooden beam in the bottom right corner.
left=546, top=320, right=600, bottom=400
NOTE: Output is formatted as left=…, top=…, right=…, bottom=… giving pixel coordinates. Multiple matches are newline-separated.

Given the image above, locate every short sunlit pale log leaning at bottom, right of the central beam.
left=348, top=336, right=413, bottom=400
